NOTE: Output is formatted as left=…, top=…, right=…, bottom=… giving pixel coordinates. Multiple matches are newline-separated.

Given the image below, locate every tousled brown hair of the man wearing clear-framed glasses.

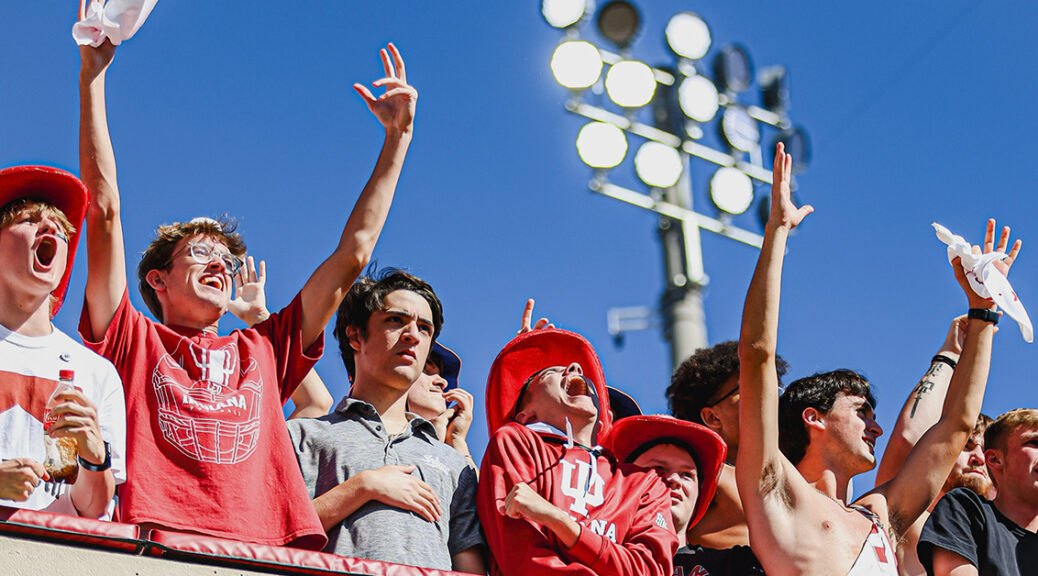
left=137, top=216, right=245, bottom=322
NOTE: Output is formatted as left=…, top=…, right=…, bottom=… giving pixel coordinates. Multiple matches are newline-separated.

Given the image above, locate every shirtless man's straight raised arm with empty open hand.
left=735, top=144, right=814, bottom=500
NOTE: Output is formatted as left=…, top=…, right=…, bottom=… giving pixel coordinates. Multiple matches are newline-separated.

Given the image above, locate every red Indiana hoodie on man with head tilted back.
left=477, top=422, right=678, bottom=576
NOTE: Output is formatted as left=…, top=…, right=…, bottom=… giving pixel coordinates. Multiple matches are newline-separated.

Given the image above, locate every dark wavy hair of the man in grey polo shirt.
left=334, top=264, right=443, bottom=381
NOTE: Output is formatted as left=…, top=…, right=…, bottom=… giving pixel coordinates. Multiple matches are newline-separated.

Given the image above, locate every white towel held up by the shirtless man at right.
left=933, top=222, right=1035, bottom=342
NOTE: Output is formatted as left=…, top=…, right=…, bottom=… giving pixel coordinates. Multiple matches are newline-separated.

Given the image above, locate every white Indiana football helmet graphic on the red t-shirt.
left=152, top=345, right=263, bottom=464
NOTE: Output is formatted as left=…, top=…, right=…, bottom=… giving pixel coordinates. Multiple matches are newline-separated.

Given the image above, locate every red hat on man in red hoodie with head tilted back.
left=487, top=328, right=612, bottom=436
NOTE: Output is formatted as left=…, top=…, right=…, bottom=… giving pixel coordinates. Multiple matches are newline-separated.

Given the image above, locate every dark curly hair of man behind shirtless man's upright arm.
left=666, top=340, right=789, bottom=424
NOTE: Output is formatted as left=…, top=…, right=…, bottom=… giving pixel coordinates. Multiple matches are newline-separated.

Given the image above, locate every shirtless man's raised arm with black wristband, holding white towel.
left=863, top=220, right=1020, bottom=536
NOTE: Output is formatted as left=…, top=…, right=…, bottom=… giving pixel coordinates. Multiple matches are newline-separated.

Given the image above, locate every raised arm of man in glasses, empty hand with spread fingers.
left=302, top=44, right=418, bottom=346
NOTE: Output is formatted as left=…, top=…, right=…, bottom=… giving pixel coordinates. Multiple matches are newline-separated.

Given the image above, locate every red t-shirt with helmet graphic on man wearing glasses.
left=79, top=293, right=327, bottom=550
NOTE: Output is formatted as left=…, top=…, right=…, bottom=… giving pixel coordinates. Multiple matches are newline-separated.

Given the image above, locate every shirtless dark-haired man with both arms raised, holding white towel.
left=736, top=144, right=1019, bottom=576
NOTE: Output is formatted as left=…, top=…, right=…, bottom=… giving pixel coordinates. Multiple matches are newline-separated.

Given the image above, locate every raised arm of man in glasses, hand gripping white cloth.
left=79, top=40, right=127, bottom=339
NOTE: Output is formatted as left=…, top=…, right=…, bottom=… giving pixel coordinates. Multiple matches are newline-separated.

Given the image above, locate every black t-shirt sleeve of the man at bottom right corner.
left=917, top=488, right=986, bottom=576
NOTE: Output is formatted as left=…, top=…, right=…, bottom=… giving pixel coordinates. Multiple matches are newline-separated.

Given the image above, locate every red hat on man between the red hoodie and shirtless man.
left=602, top=415, right=728, bottom=527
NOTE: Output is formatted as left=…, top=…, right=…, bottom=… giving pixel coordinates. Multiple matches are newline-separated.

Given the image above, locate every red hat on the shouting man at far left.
left=0, top=166, right=90, bottom=318
